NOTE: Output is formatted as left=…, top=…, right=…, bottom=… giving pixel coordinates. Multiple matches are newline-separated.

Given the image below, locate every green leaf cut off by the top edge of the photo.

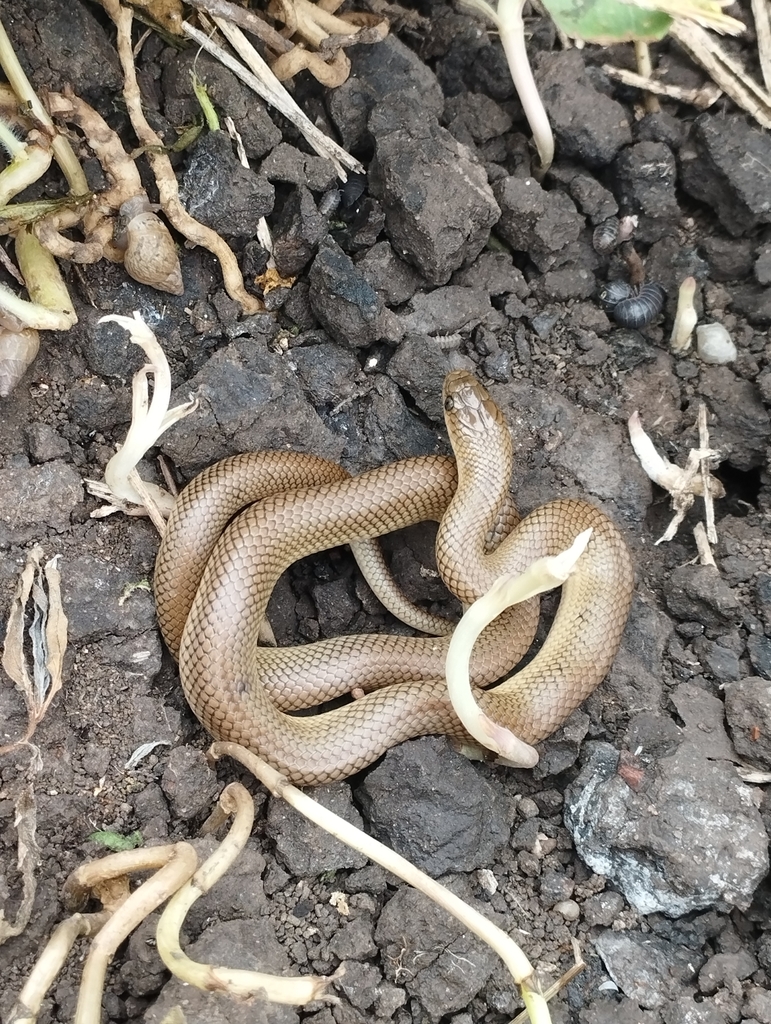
left=544, top=0, right=672, bottom=45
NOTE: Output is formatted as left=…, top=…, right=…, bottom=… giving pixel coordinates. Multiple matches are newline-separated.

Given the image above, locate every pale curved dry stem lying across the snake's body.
left=445, top=527, right=592, bottom=768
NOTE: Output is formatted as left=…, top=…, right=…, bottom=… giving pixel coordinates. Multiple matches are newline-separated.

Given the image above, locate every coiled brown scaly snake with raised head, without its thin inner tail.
left=155, top=372, right=633, bottom=784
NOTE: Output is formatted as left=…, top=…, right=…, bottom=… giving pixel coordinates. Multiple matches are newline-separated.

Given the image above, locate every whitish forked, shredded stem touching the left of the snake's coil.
left=86, top=312, right=198, bottom=516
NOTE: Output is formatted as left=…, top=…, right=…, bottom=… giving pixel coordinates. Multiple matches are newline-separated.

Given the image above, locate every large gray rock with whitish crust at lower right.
left=565, top=683, right=768, bottom=918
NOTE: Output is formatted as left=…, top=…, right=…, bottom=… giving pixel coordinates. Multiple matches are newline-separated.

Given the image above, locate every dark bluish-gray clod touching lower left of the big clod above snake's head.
left=309, top=239, right=383, bottom=348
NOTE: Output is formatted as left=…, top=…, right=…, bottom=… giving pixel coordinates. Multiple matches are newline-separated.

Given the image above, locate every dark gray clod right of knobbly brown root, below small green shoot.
left=179, top=131, right=274, bottom=241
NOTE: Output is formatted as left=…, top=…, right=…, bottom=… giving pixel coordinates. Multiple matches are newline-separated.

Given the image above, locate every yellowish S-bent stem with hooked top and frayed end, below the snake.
left=156, top=782, right=332, bottom=1006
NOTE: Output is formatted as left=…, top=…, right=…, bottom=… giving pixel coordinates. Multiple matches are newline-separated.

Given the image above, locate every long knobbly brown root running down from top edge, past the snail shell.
left=101, top=0, right=263, bottom=313
